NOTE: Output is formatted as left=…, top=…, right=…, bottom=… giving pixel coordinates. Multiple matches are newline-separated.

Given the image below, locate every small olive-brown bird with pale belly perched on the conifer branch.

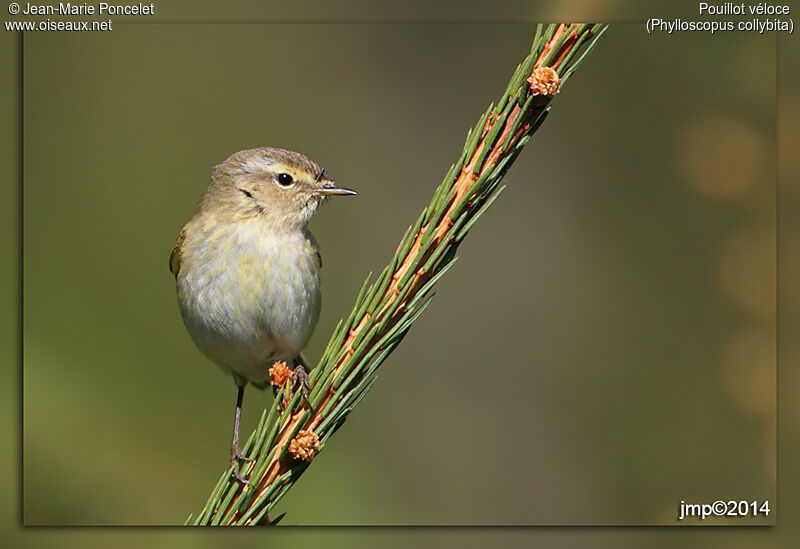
left=169, top=147, right=356, bottom=483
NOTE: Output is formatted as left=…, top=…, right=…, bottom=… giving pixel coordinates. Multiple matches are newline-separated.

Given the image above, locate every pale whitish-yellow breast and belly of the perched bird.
left=178, top=231, right=320, bottom=386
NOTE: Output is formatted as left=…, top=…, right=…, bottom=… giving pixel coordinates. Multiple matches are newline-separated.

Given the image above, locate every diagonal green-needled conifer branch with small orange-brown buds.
left=187, top=24, right=606, bottom=525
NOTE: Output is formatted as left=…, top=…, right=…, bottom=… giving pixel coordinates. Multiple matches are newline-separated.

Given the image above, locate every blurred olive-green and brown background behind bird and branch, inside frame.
left=1, top=0, right=796, bottom=540
